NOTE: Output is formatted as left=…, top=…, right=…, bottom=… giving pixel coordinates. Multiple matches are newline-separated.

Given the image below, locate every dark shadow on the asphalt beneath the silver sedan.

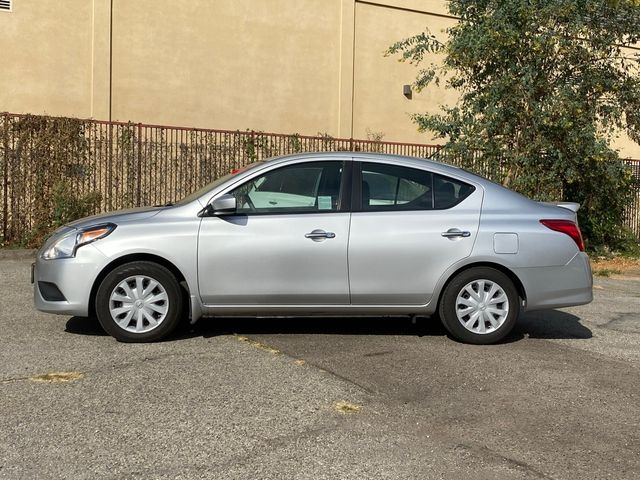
left=65, top=310, right=592, bottom=343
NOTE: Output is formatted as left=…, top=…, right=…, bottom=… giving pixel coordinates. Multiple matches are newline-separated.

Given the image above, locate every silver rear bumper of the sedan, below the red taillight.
left=513, top=252, right=593, bottom=311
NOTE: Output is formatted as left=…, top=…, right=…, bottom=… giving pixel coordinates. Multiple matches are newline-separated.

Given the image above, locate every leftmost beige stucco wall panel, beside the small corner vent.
left=0, top=0, right=100, bottom=117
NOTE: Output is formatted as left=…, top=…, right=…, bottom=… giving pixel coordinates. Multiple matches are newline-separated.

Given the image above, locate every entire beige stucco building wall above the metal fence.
left=0, top=0, right=640, bottom=158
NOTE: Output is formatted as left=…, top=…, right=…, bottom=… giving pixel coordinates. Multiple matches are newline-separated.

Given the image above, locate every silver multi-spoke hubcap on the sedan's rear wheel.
left=456, top=279, right=509, bottom=334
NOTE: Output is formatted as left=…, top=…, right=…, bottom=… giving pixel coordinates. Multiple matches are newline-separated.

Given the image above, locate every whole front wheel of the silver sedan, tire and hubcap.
left=96, top=262, right=182, bottom=342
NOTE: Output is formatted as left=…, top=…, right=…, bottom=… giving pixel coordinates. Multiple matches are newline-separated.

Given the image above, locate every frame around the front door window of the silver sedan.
left=212, top=158, right=353, bottom=217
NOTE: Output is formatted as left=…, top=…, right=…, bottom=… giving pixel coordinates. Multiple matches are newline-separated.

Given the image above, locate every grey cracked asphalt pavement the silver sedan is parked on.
left=0, top=252, right=640, bottom=479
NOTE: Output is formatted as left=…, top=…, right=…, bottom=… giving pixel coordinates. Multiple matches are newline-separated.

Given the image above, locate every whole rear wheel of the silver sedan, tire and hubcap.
left=439, top=267, right=520, bottom=345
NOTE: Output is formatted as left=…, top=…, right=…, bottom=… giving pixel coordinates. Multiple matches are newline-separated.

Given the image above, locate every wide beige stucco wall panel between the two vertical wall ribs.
left=112, top=0, right=341, bottom=134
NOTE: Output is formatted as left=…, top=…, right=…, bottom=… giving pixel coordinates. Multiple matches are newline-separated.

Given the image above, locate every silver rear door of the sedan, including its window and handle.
left=349, top=162, right=482, bottom=305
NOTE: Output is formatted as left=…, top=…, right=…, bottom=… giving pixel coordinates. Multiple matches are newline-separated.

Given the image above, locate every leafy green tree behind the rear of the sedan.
left=387, top=0, right=640, bottom=247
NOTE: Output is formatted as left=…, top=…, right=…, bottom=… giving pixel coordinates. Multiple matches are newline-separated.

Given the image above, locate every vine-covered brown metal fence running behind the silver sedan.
left=0, top=113, right=640, bottom=246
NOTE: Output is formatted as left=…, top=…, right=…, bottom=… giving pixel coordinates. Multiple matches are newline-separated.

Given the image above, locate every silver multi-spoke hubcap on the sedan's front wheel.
left=109, top=275, right=169, bottom=333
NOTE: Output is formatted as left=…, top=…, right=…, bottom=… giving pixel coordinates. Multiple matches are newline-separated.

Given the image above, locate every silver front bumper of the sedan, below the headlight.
left=32, top=245, right=107, bottom=317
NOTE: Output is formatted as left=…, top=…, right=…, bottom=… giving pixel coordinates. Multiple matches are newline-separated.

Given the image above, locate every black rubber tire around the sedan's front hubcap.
left=95, top=262, right=183, bottom=343
